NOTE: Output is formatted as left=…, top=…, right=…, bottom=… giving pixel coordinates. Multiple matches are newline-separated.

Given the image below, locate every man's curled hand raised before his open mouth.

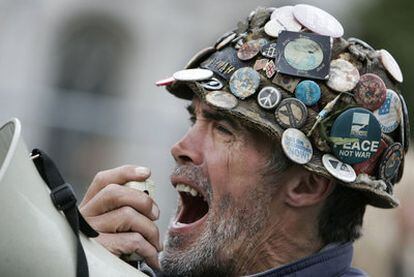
left=80, top=165, right=162, bottom=268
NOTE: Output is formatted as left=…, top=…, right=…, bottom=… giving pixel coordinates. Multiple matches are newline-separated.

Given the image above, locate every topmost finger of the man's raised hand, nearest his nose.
left=80, top=165, right=151, bottom=206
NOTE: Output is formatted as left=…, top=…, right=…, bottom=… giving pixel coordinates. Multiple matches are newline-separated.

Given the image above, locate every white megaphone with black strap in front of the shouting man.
left=0, top=119, right=146, bottom=277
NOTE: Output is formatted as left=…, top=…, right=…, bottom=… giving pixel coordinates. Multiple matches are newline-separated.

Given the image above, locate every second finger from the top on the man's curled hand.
left=81, top=184, right=160, bottom=220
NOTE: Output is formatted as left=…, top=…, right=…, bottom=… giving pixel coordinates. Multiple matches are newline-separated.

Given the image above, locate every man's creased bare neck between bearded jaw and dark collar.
left=233, top=207, right=323, bottom=276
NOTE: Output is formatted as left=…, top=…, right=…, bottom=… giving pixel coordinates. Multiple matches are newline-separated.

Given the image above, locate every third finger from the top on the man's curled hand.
left=88, top=206, right=162, bottom=251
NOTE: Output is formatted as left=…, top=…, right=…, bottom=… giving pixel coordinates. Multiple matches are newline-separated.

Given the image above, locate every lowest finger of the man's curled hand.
left=95, top=233, right=160, bottom=269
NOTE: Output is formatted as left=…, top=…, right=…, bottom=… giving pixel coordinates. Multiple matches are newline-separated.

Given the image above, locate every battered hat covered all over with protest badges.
left=157, top=5, right=409, bottom=208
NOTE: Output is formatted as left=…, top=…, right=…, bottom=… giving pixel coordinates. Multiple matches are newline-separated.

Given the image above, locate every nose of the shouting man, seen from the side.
left=171, top=125, right=203, bottom=165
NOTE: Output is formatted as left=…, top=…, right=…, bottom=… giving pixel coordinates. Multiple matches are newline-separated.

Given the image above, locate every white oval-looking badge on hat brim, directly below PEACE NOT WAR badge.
left=322, top=154, right=356, bottom=183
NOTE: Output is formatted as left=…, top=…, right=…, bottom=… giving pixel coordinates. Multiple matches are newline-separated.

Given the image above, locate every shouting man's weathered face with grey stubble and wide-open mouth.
left=161, top=98, right=290, bottom=276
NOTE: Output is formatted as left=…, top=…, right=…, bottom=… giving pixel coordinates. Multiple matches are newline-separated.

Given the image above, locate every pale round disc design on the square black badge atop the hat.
left=284, top=37, right=324, bottom=71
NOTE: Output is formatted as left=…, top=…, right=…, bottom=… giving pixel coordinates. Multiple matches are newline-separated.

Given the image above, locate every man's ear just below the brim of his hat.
left=285, top=167, right=335, bottom=207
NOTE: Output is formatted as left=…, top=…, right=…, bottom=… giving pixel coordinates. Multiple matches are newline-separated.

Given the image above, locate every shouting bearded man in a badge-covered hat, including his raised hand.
left=77, top=5, right=409, bottom=276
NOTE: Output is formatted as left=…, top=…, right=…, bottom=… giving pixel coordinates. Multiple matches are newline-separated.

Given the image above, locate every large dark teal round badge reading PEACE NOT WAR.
left=330, top=108, right=381, bottom=164
